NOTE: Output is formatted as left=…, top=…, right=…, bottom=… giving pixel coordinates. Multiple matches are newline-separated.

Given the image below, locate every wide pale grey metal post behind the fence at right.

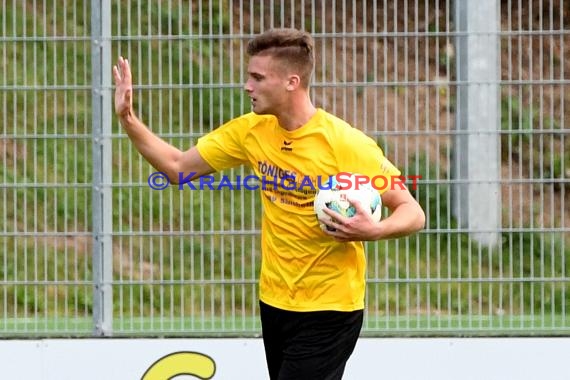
left=453, top=0, right=501, bottom=246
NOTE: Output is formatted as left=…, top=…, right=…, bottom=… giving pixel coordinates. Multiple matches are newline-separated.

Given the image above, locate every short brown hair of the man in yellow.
left=247, top=28, right=315, bottom=88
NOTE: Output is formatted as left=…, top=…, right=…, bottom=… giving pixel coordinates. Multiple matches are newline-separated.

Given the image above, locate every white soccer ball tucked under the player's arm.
left=314, top=173, right=382, bottom=231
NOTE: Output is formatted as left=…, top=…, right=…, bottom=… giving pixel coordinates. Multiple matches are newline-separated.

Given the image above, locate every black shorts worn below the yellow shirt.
left=259, top=302, right=364, bottom=380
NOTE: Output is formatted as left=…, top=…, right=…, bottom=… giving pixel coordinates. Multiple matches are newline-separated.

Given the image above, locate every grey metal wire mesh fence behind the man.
left=0, top=0, right=570, bottom=336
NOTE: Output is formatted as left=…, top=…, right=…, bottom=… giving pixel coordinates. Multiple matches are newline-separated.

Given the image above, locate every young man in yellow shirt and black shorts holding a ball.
left=113, top=29, right=425, bottom=380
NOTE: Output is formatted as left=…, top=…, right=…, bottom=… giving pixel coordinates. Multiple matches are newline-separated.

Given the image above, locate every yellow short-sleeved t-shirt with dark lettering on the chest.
left=197, top=109, right=400, bottom=311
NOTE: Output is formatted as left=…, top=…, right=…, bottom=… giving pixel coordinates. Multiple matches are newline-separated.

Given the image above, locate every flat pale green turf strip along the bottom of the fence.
left=0, top=315, right=570, bottom=337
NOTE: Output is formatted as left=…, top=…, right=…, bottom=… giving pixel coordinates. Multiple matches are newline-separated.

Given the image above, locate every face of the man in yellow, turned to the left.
left=244, top=55, right=288, bottom=115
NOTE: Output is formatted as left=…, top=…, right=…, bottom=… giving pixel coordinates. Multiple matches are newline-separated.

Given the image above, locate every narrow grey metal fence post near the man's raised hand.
left=91, top=0, right=113, bottom=336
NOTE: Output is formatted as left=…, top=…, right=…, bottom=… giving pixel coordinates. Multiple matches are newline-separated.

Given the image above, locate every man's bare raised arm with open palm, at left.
left=113, top=57, right=215, bottom=183
